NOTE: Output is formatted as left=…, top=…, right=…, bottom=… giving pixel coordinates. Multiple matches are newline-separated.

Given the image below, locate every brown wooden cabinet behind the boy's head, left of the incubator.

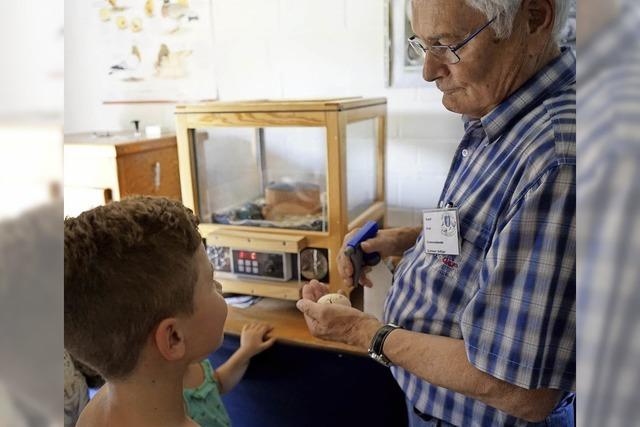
left=64, top=132, right=181, bottom=215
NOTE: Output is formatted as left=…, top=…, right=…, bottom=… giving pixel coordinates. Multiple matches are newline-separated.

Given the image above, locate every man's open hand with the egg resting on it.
left=296, top=280, right=382, bottom=349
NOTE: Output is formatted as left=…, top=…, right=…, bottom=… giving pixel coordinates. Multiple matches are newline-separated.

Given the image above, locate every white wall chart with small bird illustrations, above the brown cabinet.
left=92, top=0, right=216, bottom=102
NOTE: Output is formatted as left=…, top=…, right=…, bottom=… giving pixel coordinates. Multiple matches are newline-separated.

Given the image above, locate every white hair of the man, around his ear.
left=465, top=0, right=571, bottom=41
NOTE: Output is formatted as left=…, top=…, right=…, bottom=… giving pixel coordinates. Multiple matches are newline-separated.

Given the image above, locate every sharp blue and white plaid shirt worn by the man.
left=385, top=49, right=576, bottom=426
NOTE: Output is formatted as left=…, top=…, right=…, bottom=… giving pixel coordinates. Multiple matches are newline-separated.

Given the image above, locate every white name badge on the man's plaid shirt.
left=422, top=208, right=460, bottom=255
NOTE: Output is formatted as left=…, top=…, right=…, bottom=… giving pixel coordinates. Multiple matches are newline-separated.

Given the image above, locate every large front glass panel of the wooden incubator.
left=194, top=127, right=327, bottom=231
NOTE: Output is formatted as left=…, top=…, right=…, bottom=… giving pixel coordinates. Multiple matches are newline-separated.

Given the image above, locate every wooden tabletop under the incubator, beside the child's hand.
left=224, top=298, right=366, bottom=355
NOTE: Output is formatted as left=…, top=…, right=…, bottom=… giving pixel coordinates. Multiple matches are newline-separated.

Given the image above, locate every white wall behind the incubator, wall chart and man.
left=65, top=0, right=462, bottom=224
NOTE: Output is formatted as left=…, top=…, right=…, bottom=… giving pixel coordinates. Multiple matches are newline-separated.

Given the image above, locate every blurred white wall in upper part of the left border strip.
left=0, top=0, right=64, bottom=219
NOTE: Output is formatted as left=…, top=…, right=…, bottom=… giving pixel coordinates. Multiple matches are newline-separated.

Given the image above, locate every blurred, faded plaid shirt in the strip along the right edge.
left=577, top=1, right=640, bottom=427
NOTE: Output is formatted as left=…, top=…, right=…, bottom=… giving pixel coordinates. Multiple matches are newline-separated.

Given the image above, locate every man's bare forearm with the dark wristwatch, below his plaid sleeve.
left=353, top=320, right=559, bottom=421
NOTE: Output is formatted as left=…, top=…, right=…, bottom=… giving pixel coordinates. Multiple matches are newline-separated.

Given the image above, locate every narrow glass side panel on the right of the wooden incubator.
left=347, top=119, right=378, bottom=222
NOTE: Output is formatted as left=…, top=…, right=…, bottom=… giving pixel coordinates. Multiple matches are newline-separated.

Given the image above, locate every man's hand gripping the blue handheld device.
left=337, top=228, right=421, bottom=288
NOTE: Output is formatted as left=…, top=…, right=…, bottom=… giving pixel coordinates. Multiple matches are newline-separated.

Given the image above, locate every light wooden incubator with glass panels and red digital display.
left=176, top=98, right=386, bottom=300
